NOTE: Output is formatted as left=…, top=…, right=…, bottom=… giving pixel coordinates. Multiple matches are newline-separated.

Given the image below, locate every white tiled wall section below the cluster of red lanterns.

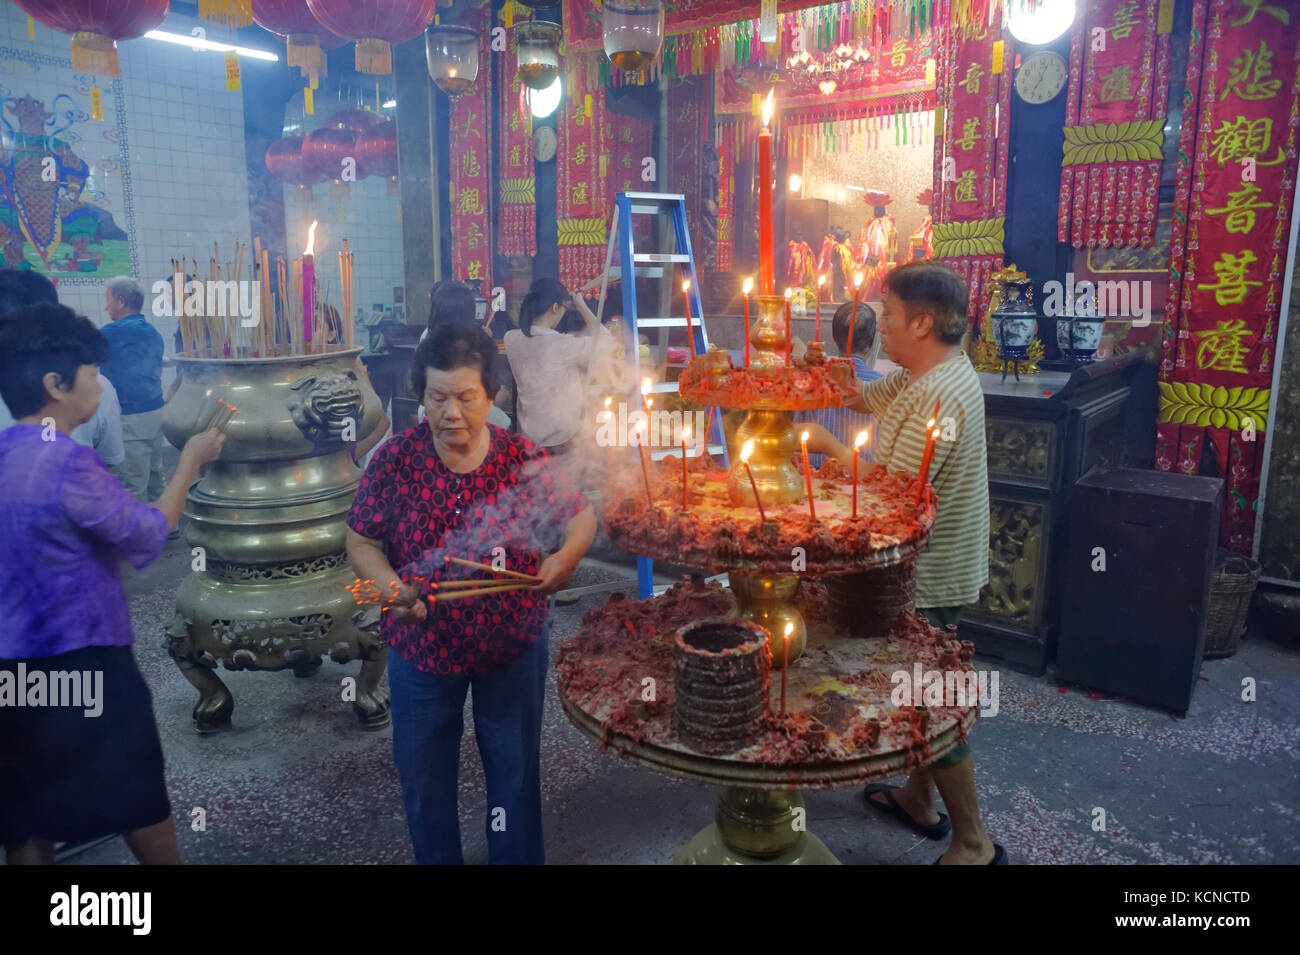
left=285, top=92, right=403, bottom=324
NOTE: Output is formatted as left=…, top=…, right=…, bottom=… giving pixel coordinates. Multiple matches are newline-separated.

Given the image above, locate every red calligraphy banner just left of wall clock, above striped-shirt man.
left=932, top=0, right=1011, bottom=325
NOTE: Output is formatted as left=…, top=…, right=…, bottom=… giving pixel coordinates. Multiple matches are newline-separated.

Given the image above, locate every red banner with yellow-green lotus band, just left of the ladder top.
left=555, top=57, right=614, bottom=288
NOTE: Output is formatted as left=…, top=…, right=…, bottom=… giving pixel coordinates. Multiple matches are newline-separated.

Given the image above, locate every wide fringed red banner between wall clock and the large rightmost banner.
left=1057, top=0, right=1170, bottom=248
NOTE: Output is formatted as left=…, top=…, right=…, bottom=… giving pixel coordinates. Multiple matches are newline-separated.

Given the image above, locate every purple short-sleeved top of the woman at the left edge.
left=0, top=425, right=168, bottom=660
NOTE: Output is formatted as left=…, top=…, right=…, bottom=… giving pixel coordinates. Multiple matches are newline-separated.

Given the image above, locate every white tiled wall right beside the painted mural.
left=0, top=3, right=250, bottom=351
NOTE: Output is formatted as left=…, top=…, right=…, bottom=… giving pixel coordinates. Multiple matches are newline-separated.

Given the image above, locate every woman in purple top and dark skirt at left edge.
left=0, top=305, right=224, bottom=864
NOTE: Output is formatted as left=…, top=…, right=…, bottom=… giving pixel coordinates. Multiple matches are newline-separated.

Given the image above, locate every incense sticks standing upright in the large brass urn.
left=172, top=236, right=356, bottom=359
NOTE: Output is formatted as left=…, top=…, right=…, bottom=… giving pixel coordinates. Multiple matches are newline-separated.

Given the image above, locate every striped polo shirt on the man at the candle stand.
left=862, top=353, right=988, bottom=607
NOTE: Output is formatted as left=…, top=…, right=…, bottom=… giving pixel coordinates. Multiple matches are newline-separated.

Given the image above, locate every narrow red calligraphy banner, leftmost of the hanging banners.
left=450, top=8, right=493, bottom=292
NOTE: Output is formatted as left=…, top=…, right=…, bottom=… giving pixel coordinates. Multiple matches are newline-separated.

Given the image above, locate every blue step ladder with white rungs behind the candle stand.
left=595, top=192, right=729, bottom=600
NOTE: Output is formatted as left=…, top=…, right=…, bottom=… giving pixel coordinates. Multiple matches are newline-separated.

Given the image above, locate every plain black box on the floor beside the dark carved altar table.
left=1056, top=466, right=1223, bottom=715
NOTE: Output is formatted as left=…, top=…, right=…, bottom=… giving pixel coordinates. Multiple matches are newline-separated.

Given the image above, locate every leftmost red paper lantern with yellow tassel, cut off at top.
left=14, top=0, right=169, bottom=77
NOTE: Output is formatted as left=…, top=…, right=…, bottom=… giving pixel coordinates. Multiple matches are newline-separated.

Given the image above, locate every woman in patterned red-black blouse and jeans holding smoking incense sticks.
left=347, top=324, right=595, bottom=864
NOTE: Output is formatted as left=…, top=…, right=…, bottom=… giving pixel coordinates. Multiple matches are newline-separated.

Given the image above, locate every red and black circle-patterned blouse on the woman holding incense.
left=347, top=422, right=586, bottom=677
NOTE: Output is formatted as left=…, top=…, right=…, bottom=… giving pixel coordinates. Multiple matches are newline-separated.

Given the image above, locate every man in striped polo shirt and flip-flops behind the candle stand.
left=809, top=261, right=1006, bottom=865
